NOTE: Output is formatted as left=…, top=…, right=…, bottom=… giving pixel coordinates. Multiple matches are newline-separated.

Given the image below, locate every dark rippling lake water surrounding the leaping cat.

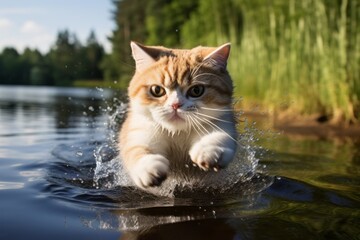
left=0, top=87, right=360, bottom=240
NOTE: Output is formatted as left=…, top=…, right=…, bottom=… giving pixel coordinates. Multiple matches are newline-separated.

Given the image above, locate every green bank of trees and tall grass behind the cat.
left=104, top=0, right=360, bottom=121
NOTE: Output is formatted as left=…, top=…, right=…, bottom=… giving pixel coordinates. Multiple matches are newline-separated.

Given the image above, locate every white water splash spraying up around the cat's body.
left=94, top=99, right=268, bottom=197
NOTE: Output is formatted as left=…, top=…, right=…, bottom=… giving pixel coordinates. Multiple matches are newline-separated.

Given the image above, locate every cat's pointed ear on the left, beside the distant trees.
left=130, top=41, right=161, bottom=71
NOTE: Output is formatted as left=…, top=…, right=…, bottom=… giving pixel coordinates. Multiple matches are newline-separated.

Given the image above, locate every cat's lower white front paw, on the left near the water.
left=130, top=154, right=170, bottom=188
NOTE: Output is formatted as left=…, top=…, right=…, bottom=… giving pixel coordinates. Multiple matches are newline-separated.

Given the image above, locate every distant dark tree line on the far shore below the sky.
left=0, top=30, right=105, bottom=86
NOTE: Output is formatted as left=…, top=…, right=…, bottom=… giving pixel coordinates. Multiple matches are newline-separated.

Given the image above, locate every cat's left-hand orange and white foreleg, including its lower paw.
left=120, top=117, right=170, bottom=188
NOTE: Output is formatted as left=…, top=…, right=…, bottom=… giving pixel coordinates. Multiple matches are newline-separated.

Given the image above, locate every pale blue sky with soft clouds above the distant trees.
left=0, top=0, right=115, bottom=53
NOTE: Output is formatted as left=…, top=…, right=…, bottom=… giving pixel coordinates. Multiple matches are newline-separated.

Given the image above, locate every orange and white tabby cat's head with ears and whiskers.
left=128, top=42, right=233, bottom=133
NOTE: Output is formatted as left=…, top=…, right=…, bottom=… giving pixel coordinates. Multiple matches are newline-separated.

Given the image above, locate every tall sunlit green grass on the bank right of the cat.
left=185, top=0, right=360, bottom=121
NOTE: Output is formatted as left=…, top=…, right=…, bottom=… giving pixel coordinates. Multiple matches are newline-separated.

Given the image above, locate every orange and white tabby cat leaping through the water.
left=119, top=42, right=238, bottom=189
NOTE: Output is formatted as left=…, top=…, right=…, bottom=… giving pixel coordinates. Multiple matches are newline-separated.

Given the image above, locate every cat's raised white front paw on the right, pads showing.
left=189, top=131, right=237, bottom=171
